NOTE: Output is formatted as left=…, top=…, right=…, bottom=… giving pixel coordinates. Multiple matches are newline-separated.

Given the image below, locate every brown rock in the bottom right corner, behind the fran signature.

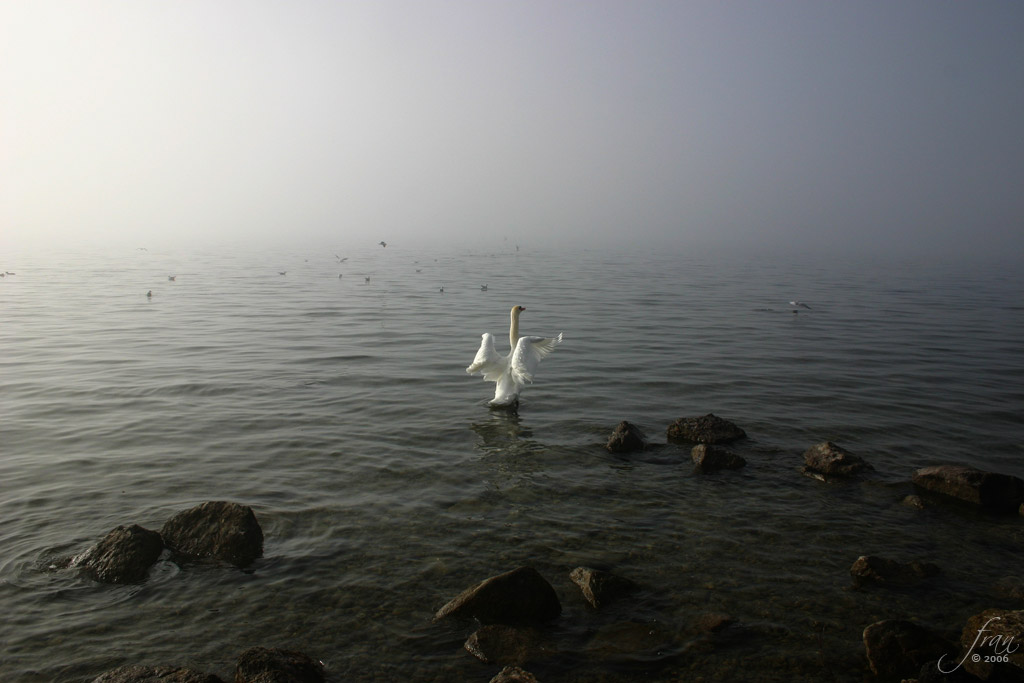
left=958, top=609, right=1024, bottom=682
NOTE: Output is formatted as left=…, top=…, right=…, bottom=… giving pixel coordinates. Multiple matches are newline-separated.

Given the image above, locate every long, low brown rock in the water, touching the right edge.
left=912, top=465, right=1024, bottom=513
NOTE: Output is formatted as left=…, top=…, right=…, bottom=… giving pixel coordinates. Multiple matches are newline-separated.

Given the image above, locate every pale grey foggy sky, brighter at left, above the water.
left=0, top=0, right=1024, bottom=258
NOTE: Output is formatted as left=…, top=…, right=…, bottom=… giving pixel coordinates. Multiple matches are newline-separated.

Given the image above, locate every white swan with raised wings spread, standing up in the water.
left=466, top=306, right=562, bottom=405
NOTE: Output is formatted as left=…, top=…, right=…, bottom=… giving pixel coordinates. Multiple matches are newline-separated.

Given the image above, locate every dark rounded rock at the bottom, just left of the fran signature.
left=863, top=620, right=956, bottom=680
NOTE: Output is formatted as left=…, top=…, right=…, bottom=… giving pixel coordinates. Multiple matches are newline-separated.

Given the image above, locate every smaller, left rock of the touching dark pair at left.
left=71, top=524, right=164, bottom=584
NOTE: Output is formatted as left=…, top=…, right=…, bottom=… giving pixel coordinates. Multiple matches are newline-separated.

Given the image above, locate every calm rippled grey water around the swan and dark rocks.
left=0, top=242, right=1024, bottom=682
